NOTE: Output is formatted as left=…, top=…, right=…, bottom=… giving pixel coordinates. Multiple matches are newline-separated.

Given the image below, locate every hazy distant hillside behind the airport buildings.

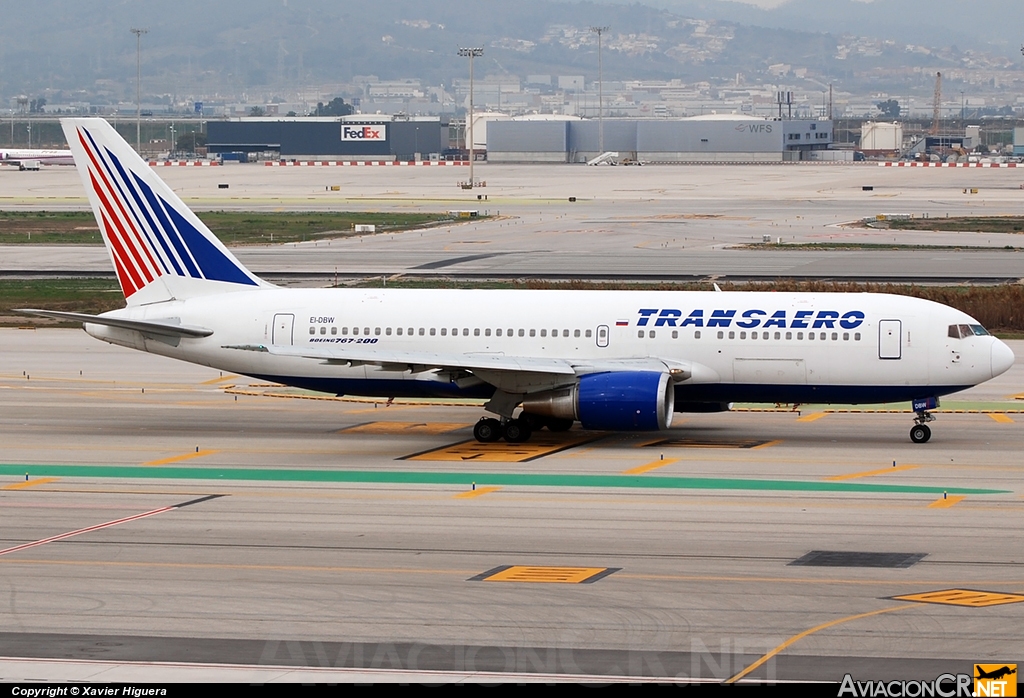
left=0, top=0, right=1020, bottom=100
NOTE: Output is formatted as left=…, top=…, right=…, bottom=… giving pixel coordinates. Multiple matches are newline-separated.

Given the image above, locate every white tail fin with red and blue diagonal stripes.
left=60, top=119, right=271, bottom=305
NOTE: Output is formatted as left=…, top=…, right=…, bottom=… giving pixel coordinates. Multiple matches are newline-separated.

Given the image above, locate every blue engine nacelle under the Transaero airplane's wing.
left=522, top=370, right=676, bottom=431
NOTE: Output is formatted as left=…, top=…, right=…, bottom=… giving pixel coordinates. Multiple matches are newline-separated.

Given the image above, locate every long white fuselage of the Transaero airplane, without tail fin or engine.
left=87, top=289, right=1013, bottom=409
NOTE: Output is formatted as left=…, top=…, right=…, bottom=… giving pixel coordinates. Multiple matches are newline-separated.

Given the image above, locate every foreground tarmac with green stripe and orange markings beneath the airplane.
left=0, top=327, right=1024, bottom=682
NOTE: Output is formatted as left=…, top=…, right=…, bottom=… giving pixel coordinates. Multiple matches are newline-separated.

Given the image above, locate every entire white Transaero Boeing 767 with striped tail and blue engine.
left=19, top=119, right=1014, bottom=443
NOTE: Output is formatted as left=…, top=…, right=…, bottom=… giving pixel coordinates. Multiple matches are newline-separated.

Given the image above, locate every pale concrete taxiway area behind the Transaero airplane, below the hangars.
left=0, top=164, right=1024, bottom=283
